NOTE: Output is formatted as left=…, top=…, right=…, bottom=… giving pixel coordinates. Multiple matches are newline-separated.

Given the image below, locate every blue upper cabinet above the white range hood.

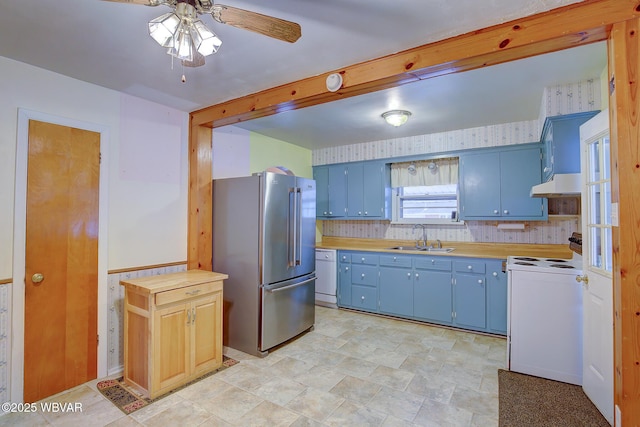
left=541, top=111, right=598, bottom=181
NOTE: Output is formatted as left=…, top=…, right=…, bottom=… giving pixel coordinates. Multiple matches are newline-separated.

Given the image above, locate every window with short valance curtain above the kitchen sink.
left=391, top=158, right=462, bottom=224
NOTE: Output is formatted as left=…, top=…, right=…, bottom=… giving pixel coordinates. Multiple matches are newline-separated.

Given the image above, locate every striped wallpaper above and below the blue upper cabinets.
left=312, top=78, right=602, bottom=244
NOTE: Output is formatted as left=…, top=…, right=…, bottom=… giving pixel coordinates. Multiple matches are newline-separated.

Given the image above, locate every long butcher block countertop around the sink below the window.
left=316, top=237, right=573, bottom=259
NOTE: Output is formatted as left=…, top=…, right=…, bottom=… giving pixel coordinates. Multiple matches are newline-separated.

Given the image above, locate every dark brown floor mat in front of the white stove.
left=498, top=369, right=609, bottom=427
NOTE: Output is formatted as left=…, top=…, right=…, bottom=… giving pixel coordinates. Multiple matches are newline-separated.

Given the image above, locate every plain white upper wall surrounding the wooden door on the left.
left=0, top=57, right=188, bottom=280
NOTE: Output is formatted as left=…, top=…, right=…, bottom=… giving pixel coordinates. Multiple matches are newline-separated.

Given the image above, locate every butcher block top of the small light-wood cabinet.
left=120, top=270, right=229, bottom=294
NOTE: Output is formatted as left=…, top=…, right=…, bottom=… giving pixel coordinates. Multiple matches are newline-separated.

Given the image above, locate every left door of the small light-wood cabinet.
left=150, top=303, right=191, bottom=398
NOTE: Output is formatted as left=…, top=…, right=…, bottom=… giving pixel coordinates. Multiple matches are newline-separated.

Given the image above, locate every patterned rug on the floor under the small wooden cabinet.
left=97, top=356, right=239, bottom=414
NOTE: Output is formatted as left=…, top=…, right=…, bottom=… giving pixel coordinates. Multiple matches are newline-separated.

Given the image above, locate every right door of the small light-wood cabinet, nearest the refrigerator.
left=189, top=292, right=222, bottom=377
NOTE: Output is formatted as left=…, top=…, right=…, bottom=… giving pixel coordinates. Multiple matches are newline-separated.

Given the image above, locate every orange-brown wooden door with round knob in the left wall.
left=24, top=120, right=100, bottom=402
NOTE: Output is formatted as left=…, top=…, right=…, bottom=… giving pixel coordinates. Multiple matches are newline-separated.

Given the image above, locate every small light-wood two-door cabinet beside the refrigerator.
left=120, top=270, right=229, bottom=399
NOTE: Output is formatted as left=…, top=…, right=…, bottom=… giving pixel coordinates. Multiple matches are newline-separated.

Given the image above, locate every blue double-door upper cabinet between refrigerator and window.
left=313, top=161, right=391, bottom=219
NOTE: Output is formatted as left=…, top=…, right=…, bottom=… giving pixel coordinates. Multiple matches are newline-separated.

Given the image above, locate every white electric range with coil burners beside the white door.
left=507, top=248, right=582, bottom=385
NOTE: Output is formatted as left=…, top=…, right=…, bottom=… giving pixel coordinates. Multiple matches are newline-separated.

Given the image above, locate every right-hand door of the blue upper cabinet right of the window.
left=500, top=148, right=547, bottom=219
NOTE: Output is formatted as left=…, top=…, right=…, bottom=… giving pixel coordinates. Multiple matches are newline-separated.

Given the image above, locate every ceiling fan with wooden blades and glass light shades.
left=105, top=0, right=302, bottom=67
